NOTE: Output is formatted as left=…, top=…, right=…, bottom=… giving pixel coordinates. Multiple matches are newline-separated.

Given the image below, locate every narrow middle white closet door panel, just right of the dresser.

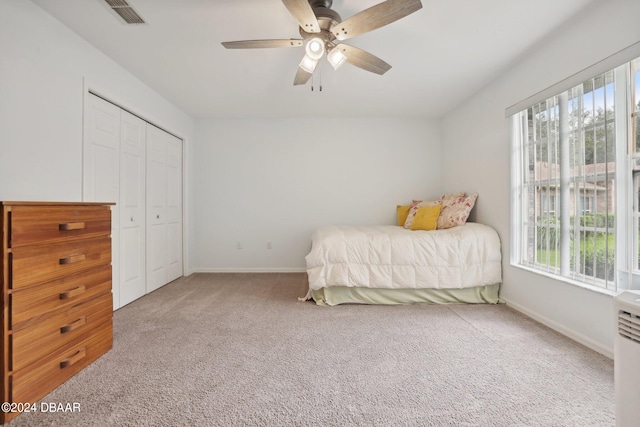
left=120, top=111, right=147, bottom=306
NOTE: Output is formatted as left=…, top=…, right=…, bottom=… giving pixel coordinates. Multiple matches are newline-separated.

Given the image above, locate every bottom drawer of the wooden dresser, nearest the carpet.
left=9, top=319, right=113, bottom=402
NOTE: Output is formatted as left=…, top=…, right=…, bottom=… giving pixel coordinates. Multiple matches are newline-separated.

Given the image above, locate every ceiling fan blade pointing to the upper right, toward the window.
left=331, top=0, right=422, bottom=40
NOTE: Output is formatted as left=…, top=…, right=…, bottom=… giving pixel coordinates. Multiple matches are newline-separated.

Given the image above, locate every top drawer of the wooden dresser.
left=8, top=206, right=111, bottom=248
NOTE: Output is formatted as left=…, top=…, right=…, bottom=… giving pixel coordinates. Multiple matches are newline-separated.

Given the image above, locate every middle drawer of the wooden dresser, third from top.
left=10, top=265, right=113, bottom=332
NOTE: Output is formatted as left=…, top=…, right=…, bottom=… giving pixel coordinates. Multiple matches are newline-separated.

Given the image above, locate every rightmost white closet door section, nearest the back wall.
left=147, top=125, right=182, bottom=292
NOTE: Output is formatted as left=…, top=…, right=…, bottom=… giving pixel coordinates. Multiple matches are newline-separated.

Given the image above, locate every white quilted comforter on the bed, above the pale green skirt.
left=305, top=223, right=502, bottom=290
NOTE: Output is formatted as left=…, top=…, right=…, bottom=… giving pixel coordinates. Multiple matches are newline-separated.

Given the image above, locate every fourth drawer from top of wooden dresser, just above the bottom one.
left=10, top=293, right=113, bottom=370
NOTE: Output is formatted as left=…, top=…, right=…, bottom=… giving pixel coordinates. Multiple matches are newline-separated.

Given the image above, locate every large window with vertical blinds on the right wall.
left=512, top=58, right=640, bottom=291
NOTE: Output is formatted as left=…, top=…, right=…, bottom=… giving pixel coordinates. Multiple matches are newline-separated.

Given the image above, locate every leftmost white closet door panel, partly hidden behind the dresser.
left=82, top=95, right=121, bottom=310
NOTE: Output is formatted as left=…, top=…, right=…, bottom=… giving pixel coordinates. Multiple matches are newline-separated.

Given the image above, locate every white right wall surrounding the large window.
left=442, top=0, right=640, bottom=355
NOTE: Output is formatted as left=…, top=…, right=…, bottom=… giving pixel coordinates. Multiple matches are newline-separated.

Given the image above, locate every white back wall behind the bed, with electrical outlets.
left=193, top=118, right=441, bottom=271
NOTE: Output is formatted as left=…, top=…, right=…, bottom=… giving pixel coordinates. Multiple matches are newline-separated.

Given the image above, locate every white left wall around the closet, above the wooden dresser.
left=0, top=0, right=194, bottom=205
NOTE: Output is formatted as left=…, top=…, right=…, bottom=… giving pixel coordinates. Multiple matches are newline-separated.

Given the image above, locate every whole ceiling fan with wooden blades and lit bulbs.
left=222, top=0, right=422, bottom=85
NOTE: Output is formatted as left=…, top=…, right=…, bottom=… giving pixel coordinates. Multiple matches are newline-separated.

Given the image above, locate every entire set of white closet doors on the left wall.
left=83, top=94, right=182, bottom=309
